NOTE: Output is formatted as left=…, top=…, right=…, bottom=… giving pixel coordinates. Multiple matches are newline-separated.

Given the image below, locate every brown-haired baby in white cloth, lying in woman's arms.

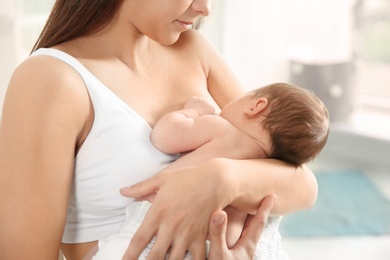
left=93, top=83, right=329, bottom=259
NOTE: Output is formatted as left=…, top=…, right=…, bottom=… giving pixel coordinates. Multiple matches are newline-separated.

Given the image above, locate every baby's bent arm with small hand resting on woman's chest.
left=150, top=97, right=215, bottom=154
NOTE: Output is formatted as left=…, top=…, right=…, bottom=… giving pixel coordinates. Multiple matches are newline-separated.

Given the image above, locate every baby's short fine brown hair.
left=251, top=82, right=329, bottom=166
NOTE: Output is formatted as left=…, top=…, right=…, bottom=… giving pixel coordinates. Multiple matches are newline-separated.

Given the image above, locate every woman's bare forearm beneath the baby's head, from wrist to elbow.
left=218, top=159, right=318, bottom=215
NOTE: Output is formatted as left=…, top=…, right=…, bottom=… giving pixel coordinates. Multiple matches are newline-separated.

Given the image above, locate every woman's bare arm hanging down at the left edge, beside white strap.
left=0, top=56, right=89, bottom=259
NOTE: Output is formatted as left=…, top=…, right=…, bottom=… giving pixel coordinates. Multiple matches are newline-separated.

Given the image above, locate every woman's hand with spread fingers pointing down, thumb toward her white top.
left=121, top=160, right=234, bottom=260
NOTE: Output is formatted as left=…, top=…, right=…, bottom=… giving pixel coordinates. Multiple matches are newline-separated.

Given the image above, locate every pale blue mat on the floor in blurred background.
left=280, top=170, right=390, bottom=237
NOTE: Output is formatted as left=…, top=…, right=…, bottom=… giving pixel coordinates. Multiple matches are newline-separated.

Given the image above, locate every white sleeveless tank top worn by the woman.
left=32, top=49, right=176, bottom=243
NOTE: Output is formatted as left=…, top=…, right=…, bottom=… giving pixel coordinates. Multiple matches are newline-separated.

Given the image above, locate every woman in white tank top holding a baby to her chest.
left=0, top=0, right=317, bottom=260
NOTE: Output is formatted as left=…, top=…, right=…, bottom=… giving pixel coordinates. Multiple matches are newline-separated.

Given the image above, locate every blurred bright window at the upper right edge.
left=356, top=0, right=390, bottom=107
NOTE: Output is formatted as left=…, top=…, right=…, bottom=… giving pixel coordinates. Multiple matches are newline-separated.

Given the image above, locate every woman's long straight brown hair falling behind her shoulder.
left=31, top=0, right=123, bottom=52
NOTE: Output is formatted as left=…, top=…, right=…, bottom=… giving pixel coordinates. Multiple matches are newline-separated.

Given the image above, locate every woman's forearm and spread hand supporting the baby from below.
left=121, top=155, right=317, bottom=259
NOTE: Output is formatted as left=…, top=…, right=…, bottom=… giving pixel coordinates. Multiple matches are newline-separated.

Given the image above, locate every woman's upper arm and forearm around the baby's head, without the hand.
left=194, top=30, right=317, bottom=215
